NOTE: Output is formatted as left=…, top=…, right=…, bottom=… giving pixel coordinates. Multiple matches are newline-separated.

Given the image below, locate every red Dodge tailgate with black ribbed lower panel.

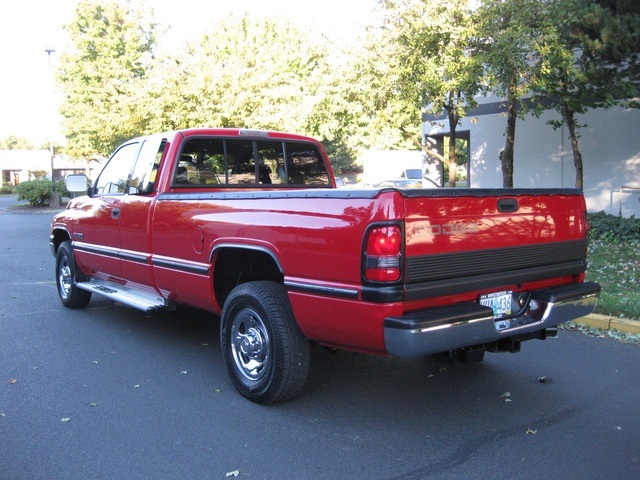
left=403, top=189, right=587, bottom=300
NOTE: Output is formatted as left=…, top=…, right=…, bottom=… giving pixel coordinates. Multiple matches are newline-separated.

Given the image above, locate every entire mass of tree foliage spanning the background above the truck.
left=52, top=0, right=640, bottom=184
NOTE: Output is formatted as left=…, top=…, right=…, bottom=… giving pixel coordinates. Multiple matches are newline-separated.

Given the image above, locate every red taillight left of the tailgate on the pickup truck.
left=364, top=225, right=402, bottom=282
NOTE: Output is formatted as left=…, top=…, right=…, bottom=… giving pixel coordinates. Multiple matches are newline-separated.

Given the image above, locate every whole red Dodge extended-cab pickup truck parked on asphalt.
left=50, top=129, right=600, bottom=403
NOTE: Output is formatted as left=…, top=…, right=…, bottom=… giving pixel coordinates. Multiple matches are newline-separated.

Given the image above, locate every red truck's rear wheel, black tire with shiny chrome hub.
left=220, top=281, right=311, bottom=404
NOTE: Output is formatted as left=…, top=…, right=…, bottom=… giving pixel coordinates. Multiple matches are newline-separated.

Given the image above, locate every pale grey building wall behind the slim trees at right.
left=423, top=97, right=640, bottom=216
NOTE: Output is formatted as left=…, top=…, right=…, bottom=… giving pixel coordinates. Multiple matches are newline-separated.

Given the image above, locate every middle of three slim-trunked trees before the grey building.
left=476, top=0, right=547, bottom=188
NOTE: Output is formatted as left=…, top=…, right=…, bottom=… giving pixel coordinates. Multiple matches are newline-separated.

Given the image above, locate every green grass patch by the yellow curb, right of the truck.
left=586, top=239, right=640, bottom=319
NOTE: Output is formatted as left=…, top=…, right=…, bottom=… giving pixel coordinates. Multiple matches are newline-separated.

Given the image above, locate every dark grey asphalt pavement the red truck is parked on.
left=0, top=200, right=640, bottom=480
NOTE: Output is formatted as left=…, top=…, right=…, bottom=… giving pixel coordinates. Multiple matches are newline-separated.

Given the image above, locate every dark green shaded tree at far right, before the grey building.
left=533, top=0, right=640, bottom=188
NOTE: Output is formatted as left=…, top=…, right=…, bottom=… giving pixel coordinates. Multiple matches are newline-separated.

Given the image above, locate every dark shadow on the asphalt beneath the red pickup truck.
left=77, top=298, right=570, bottom=416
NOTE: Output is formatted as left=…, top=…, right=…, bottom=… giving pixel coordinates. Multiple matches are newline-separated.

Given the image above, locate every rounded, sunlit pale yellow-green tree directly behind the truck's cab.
left=151, top=14, right=329, bottom=137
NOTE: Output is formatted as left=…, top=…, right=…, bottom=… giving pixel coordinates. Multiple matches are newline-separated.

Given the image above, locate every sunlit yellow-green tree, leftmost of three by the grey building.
left=358, top=0, right=481, bottom=187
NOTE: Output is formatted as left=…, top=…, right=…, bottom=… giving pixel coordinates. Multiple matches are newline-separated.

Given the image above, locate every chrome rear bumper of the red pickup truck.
left=384, top=282, right=600, bottom=357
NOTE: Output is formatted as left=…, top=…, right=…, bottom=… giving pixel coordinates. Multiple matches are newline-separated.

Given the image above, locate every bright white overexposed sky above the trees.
left=0, top=0, right=376, bottom=145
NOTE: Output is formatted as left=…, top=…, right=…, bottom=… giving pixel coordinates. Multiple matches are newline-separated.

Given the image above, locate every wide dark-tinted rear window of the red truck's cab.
left=173, top=138, right=329, bottom=187
